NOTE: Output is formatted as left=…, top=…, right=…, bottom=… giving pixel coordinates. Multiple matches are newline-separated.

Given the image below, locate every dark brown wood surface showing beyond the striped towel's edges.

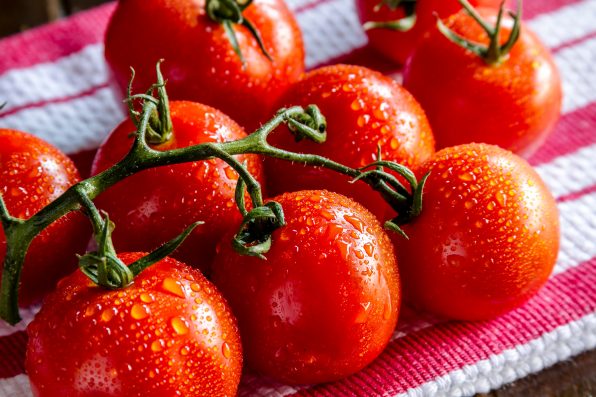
left=0, top=0, right=596, bottom=397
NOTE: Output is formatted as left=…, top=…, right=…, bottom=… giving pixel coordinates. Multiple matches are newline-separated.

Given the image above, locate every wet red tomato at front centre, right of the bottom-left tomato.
left=213, top=190, right=400, bottom=384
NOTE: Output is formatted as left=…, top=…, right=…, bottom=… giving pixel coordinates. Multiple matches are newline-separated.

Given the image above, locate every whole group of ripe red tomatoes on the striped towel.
left=0, top=0, right=561, bottom=397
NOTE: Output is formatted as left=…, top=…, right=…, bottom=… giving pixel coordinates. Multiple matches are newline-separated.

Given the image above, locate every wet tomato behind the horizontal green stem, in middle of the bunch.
left=265, top=65, right=434, bottom=220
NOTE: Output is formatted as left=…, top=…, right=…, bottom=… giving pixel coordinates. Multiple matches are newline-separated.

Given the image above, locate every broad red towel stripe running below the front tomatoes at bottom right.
left=292, top=257, right=596, bottom=397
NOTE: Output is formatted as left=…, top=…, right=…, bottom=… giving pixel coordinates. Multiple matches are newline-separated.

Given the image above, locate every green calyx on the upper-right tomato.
left=437, top=0, right=522, bottom=65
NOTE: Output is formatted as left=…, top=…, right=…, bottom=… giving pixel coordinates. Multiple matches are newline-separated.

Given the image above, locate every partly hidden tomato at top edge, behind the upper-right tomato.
left=356, top=0, right=502, bottom=64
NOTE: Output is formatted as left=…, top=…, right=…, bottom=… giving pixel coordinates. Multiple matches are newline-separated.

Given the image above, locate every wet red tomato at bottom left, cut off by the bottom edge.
left=26, top=253, right=242, bottom=397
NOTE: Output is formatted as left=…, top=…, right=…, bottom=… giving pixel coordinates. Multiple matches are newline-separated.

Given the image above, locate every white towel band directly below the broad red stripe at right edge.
left=535, top=142, right=596, bottom=198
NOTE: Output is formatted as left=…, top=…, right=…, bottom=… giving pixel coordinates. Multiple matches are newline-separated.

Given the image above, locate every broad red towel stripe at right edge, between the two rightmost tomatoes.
left=528, top=102, right=596, bottom=166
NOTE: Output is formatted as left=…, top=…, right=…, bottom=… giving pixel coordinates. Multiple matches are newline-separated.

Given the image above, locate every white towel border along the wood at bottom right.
left=398, top=313, right=596, bottom=397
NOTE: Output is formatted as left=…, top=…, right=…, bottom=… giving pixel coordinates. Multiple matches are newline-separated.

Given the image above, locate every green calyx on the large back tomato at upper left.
left=205, top=0, right=273, bottom=67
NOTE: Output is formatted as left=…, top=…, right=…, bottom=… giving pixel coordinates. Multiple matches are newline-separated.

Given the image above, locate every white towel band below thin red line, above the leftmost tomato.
left=0, top=88, right=125, bottom=153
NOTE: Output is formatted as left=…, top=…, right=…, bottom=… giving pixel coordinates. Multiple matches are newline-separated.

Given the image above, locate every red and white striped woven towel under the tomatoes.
left=0, top=0, right=596, bottom=397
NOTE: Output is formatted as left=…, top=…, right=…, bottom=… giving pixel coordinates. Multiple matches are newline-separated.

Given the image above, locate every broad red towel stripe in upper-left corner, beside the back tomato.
left=0, top=3, right=114, bottom=74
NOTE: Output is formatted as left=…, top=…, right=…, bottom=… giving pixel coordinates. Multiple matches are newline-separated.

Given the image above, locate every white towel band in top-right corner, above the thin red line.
left=527, top=0, right=596, bottom=48
